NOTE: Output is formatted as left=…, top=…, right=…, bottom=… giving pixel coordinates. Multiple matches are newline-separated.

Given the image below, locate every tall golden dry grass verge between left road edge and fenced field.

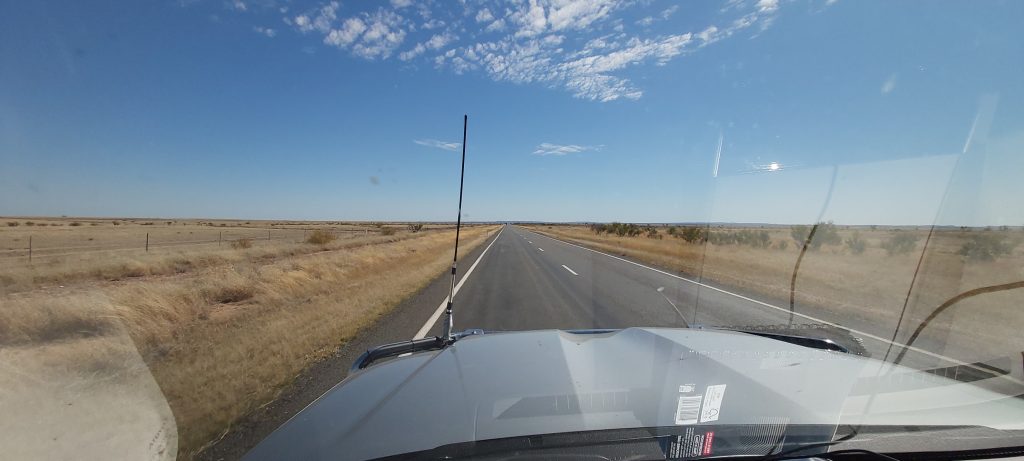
left=0, top=226, right=496, bottom=457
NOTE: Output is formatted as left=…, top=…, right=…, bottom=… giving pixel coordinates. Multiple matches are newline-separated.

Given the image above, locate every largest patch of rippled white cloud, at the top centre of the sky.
left=276, top=0, right=785, bottom=101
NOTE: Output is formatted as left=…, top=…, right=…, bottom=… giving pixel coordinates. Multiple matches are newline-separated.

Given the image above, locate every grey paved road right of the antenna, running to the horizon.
left=423, top=225, right=983, bottom=369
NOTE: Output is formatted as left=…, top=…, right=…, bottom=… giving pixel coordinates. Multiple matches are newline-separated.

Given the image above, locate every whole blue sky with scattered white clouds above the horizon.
left=0, top=0, right=1024, bottom=225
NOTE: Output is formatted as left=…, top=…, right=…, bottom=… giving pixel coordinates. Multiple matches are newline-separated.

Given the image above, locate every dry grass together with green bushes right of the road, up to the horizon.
left=527, top=222, right=1024, bottom=360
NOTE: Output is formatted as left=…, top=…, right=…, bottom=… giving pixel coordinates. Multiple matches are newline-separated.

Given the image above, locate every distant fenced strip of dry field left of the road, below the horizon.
left=0, top=219, right=456, bottom=296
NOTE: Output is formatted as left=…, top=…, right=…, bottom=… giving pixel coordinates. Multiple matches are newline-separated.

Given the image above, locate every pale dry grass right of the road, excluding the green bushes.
left=532, top=225, right=1024, bottom=361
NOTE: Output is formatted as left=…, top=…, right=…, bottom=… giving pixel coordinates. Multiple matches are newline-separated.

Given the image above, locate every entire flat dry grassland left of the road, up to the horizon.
left=0, top=218, right=498, bottom=458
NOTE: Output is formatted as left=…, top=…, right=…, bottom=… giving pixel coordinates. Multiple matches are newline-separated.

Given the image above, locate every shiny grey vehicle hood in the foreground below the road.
left=247, top=328, right=1021, bottom=459
